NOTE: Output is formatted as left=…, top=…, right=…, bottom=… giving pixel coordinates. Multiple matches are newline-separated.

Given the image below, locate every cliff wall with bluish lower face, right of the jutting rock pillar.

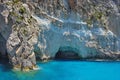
left=31, top=0, right=120, bottom=59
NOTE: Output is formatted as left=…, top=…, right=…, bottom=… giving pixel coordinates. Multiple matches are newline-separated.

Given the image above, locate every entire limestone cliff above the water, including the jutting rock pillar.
left=0, top=0, right=120, bottom=70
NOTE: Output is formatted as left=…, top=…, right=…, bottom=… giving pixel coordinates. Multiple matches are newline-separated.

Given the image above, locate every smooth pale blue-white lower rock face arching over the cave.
left=33, top=16, right=120, bottom=58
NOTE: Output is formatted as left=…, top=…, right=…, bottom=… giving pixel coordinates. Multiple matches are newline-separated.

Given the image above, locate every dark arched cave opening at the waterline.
left=55, top=47, right=80, bottom=60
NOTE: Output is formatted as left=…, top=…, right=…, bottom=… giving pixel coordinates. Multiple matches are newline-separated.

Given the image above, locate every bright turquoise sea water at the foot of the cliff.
left=0, top=61, right=120, bottom=80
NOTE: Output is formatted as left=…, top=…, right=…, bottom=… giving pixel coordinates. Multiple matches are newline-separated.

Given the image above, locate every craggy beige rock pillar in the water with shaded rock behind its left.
left=0, top=1, right=38, bottom=70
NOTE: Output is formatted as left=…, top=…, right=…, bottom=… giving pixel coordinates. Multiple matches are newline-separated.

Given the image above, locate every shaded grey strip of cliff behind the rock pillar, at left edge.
left=0, top=4, right=12, bottom=57
